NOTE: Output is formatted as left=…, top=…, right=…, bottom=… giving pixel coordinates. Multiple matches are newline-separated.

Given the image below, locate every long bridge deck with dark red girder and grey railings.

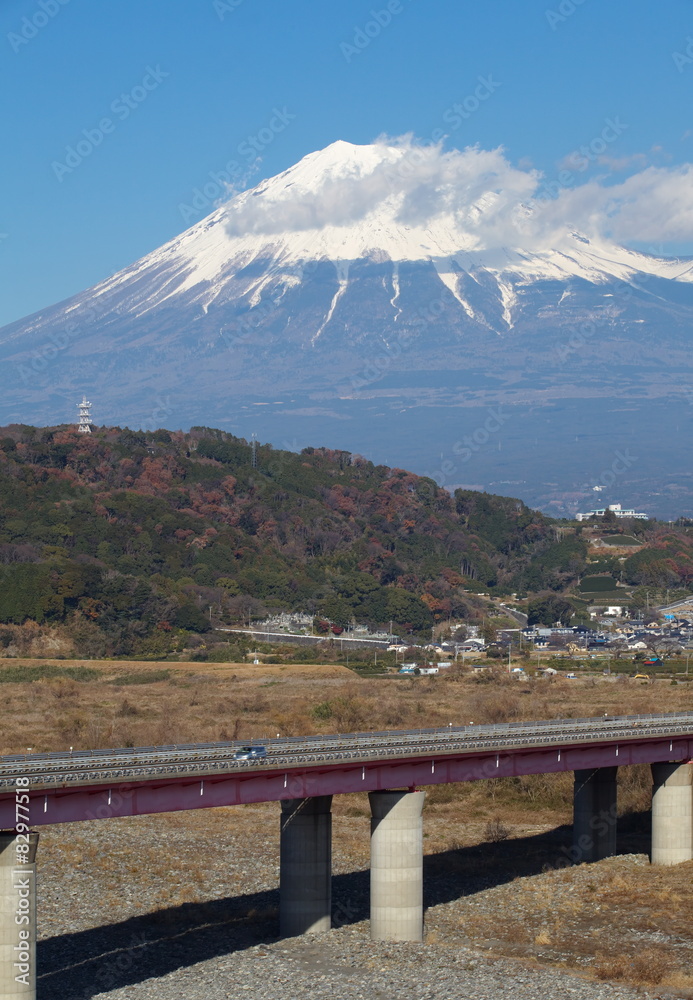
left=0, top=712, right=693, bottom=829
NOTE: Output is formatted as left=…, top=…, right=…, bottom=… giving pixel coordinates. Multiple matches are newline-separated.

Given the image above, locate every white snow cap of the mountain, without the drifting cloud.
left=79, top=141, right=693, bottom=314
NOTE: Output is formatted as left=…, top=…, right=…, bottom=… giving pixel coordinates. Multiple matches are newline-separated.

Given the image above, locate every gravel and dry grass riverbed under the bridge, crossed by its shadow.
left=33, top=803, right=693, bottom=1000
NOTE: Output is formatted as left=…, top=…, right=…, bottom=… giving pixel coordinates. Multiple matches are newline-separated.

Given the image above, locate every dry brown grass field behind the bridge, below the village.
left=0, top=659, right=693, bottom=753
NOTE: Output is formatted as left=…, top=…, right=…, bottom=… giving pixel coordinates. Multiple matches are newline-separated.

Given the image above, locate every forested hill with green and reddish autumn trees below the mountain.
left=0, top=426, right=672, bottom=654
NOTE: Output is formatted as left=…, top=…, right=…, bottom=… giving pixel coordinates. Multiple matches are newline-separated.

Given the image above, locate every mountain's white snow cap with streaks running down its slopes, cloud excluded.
left=13, top=141, right=693, bottom=343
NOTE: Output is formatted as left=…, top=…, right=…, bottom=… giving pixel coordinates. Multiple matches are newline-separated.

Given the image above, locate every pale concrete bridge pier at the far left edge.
left=0, top=831, right=38, bottom=1000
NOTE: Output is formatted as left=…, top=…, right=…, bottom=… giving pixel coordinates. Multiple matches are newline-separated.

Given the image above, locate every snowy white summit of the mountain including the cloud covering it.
left=105, top=136, right=693, bottom=308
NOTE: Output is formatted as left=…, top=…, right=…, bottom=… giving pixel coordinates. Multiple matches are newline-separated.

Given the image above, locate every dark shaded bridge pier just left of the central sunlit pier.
left=279, top=795, right=332, bottom=937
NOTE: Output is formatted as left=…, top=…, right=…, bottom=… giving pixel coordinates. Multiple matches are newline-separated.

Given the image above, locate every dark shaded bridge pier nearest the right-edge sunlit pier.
left=571, top=767, right=618, bottom=864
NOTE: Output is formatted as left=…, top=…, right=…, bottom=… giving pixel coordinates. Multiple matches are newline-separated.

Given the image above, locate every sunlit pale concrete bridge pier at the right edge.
left=651, top=761, right=693, bottom=865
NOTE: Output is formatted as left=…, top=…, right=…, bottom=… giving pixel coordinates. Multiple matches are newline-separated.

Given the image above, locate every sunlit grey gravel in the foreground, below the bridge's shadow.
left=85, top=927, right=660, bottom=1000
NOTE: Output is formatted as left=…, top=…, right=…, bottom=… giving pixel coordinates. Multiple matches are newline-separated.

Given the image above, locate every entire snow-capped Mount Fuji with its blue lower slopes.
left=0, top=141, right=693, bottom=515
